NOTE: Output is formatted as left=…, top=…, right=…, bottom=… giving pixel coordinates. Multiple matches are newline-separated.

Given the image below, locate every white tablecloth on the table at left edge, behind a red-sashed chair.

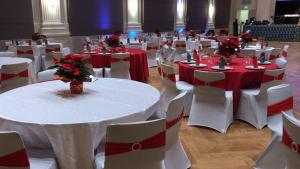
left=0, top=57, right=36, bottom=83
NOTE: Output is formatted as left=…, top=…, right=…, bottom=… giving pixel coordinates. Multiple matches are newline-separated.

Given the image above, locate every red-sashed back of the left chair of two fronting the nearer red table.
left=193, top=70, right=226, bottom=98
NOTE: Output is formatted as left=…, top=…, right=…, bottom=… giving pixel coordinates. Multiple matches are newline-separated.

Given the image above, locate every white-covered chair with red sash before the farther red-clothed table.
left=104, top=53, right=131, bottom=80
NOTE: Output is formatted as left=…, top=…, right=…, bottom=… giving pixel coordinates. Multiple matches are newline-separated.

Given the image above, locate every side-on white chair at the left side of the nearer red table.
left=160, top=64, right=193, bottom=116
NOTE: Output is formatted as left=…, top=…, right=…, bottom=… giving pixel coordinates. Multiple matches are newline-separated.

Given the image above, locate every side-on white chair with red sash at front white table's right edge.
left=164, top=92, right=191, bottom=169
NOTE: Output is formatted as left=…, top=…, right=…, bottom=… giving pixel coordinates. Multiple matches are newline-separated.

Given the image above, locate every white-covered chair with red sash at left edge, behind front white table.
left=0, top=63, right=29, bottom=93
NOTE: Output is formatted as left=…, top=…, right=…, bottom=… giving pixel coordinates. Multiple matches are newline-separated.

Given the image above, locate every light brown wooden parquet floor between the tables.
left=148, top=42, right=300, bottom=169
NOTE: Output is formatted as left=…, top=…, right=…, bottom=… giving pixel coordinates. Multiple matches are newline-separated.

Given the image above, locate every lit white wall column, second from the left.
left=125, top=0, right=142, bottom=32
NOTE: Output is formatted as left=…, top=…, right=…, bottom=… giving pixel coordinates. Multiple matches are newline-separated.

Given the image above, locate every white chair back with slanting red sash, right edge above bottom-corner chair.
left=267, top=84, right=293, bottom=117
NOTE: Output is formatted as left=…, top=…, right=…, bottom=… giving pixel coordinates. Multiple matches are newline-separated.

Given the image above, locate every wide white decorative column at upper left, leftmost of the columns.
left=32, top=0, right=70, bottom=37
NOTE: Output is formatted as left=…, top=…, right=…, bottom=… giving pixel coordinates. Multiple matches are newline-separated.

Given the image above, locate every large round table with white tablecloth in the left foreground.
left=0, top=78, right=160, bottom=169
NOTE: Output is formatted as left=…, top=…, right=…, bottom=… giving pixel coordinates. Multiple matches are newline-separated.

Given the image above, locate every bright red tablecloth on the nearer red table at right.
left=178, top=58, right=277, bottom=112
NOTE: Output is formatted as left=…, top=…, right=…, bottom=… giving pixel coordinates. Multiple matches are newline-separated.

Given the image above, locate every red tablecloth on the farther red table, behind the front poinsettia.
left=90, top=49, right=149, bottom=82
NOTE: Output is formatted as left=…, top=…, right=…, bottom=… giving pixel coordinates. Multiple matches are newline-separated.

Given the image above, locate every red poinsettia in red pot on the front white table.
left=51, top=54, right=93, bottom=94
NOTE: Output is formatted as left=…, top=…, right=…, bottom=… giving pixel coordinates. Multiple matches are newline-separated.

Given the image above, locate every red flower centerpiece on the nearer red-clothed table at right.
left=218, top=39, right=240, bottom=65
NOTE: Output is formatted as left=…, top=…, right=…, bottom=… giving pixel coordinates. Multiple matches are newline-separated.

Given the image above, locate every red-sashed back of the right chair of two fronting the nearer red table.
left=259, top=69, right=285, bottom=99
